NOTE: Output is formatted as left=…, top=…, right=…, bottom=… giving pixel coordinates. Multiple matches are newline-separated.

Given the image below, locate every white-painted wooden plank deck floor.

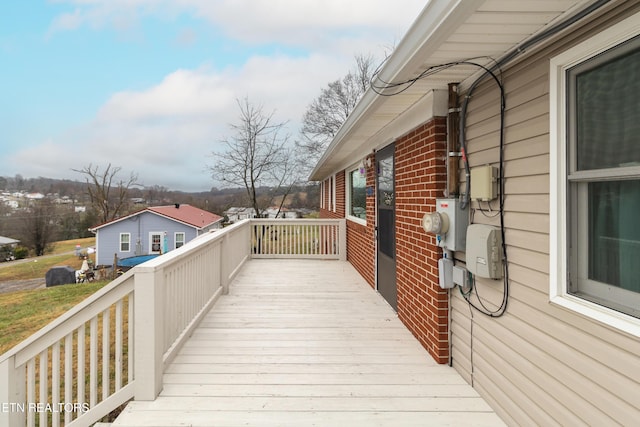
left=113, top=260, right=504, bottom=427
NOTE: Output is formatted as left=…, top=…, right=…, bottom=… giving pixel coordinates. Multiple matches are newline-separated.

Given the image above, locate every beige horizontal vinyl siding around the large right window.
left=451, top=2, right=640, bottom=426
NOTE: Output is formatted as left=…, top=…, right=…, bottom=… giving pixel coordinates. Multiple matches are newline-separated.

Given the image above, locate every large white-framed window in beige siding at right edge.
left=550, top=15, right=640, bottom=333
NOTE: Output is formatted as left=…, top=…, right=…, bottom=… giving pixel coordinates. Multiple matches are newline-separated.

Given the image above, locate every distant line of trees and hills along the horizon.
left=0, top=171, right=318, bottom=256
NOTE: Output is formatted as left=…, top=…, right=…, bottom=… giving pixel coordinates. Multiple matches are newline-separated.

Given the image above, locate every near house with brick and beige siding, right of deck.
left=310, top=0, right=640, bottom=425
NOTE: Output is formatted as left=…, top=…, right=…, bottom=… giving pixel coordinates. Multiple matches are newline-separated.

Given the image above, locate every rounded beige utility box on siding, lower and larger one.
left=466, top=224, right=502, bottom=279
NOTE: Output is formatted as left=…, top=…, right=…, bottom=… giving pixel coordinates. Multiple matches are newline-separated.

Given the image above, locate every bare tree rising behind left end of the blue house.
left=73, top=163, right=138, bottom=223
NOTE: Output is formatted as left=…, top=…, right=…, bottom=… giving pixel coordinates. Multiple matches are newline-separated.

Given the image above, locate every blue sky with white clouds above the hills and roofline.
left=0, top=0, right=426, bottom=192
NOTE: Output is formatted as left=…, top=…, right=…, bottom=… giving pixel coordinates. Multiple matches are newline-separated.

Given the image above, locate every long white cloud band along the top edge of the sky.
left=50, top=0, right=425, bottom=48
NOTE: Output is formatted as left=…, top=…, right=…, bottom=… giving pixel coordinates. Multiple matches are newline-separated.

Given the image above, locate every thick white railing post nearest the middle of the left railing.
left=134, top=266, right=164, bottom=400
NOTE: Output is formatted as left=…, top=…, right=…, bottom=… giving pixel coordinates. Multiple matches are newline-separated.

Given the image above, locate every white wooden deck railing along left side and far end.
left=0, top=220, right=346, bottom=427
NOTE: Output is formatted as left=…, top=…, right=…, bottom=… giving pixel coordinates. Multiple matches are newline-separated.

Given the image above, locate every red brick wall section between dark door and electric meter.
left=395, top=118, right=449, bottom=363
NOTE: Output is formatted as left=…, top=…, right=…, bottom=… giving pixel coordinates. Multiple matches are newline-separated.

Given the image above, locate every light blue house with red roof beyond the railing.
left=90, top=203, right=223, bottom=265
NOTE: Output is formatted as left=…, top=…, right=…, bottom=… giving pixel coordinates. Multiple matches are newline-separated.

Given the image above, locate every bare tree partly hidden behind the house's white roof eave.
left=296, top=55, right=375, bottom=170
